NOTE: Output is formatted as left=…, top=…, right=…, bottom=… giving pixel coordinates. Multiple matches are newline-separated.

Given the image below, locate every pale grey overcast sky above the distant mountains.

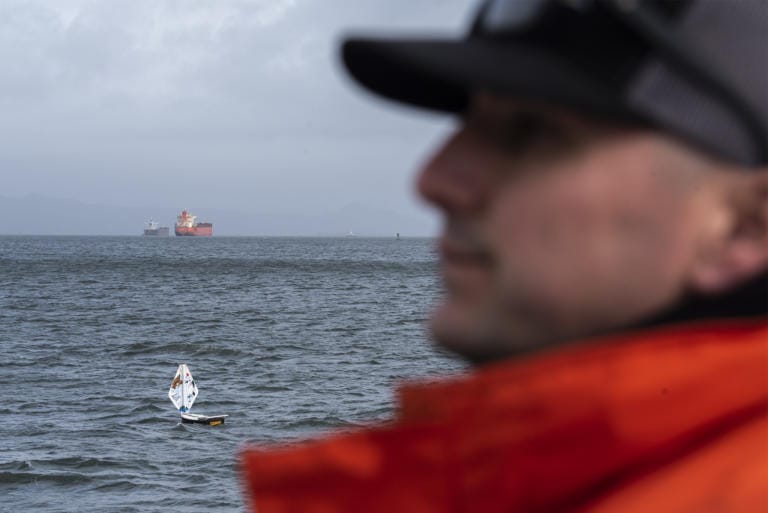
left=0, top=0, right=474, bottom=234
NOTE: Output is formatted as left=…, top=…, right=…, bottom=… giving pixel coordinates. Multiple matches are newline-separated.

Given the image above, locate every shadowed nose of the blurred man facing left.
left=416, top=129, right=491, bottom=213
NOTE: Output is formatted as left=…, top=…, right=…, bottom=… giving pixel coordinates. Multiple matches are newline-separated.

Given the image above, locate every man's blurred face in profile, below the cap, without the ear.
left=418, top=95, right=706, bottom=361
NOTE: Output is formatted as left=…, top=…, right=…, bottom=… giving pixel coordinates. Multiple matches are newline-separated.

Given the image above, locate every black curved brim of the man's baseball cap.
left=342, top=37, right=634, bottom=118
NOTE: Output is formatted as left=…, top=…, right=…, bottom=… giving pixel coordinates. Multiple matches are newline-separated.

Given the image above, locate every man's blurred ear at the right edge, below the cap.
left=691, top=169, right=768, bottom=294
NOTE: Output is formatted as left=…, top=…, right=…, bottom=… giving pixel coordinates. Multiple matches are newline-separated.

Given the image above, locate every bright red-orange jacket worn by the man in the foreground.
left=242, top=320, right=768, bottom=513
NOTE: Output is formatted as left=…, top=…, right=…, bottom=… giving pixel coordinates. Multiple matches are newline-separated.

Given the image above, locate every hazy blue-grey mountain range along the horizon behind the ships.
left=0, top=195, right=437, bottom=237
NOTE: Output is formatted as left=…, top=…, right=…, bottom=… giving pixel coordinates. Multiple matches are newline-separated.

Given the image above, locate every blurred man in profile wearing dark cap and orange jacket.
left=243, top=0, right=768, bottom=513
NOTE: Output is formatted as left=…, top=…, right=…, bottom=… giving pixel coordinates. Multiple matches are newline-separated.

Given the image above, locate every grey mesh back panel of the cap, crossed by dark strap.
left=628, top=0, right=768, bottom=165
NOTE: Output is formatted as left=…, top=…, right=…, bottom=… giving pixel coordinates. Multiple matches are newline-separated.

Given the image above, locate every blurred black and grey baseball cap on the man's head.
left=342, top=0, right=768, bottom=167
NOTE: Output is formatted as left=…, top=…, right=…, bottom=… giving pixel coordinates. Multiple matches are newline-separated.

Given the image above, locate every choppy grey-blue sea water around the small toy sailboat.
left=0, top=236, right=462, bottom=513
